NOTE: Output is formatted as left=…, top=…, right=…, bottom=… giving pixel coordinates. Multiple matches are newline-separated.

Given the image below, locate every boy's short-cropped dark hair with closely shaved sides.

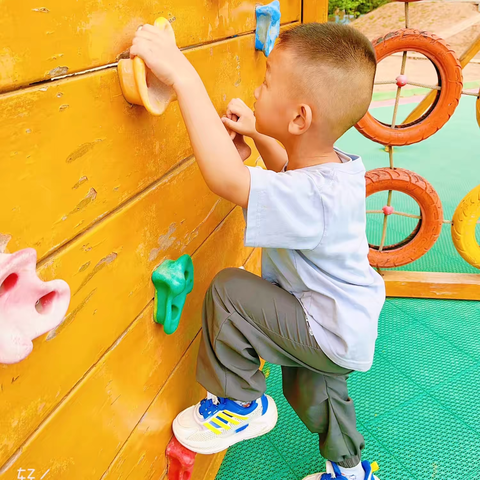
left=278, top=23, right=377, bottom=140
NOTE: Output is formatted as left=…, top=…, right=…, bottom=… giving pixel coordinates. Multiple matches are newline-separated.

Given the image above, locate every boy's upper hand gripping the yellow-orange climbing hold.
left=130, top=22, right=196, bottom=88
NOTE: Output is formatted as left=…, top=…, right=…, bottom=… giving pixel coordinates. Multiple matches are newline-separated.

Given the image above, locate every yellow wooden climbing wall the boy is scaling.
left=0, top=0, right=328, bottom=480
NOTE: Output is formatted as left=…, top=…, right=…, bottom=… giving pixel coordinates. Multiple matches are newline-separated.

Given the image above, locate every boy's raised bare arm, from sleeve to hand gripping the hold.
left=130, top=23, right=250, bottom=208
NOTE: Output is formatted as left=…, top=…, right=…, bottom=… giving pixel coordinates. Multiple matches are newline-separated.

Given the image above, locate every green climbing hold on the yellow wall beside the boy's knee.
left=152, top=255, right=193, bottom=335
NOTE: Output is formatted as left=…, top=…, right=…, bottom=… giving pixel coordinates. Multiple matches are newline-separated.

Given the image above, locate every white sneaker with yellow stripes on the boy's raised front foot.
left=173, top=395, right=278, bottom=455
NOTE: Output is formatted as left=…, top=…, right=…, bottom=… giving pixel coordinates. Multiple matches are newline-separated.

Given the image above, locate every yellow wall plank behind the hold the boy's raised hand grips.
left=0, top=28, right=288, bottom=258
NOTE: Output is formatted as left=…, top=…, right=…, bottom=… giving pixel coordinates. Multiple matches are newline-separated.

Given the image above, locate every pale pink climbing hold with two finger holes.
left=0, top=248, right=70, bottom=364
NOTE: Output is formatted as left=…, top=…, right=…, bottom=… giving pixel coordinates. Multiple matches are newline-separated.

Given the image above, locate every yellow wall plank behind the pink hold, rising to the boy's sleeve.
left=0, top=159, right=233, bottom=465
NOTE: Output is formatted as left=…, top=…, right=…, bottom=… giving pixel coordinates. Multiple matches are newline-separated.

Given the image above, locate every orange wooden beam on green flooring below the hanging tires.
left=382, top=270, right=480, bottom=300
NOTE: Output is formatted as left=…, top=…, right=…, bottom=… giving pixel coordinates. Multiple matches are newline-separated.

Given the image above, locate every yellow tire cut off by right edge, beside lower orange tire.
left=452, top=185, right=480, bottom=268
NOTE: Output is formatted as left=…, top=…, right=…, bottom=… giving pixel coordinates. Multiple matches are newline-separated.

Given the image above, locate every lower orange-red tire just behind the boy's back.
left=366, top=168, right=443, bottom=268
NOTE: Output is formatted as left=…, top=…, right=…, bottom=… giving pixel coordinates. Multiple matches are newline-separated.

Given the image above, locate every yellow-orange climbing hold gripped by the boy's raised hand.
left=117, top=17, right=176, bottom=115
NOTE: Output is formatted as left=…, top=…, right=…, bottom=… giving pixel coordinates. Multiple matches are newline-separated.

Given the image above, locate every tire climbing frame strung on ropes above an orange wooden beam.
left=356, top=0, right=480, bottom=300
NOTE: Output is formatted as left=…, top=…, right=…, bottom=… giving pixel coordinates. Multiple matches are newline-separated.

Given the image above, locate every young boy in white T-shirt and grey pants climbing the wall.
left=131, top=19, right=385, bottom=480
